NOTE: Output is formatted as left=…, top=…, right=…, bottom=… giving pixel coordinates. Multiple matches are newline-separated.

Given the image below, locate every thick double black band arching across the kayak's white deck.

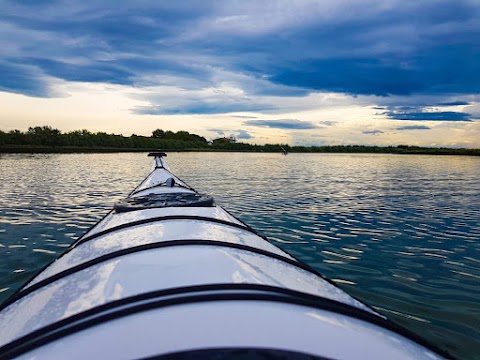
left=0, top=284, right=451, bottom=359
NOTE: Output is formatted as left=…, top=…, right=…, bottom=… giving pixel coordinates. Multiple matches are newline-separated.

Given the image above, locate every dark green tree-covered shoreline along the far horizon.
left=0, top=126, right=480, bottom=156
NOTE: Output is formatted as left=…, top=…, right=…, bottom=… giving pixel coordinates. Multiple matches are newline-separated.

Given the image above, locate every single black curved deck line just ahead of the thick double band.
left=0, top=240, right=322, bottom=311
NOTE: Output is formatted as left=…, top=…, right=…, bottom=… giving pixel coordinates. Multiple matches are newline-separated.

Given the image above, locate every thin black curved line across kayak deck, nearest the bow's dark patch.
left=72, top=215, right=267, bottom=247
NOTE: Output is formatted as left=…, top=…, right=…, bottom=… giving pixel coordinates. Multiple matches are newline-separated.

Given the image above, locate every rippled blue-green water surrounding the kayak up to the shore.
left=0, top=153, right=480, bottom=359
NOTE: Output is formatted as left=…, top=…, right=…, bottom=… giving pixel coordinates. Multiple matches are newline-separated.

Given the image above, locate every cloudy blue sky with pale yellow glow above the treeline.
left=0, top=0, right=480, bottom=148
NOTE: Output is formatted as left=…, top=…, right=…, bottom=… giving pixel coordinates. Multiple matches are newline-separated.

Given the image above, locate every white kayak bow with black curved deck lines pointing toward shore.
left=0, top=151, right=450, bottom=360
